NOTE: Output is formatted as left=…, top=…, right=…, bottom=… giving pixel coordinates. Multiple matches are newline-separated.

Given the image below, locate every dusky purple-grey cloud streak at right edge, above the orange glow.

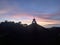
left=40, top=11, right=60, bottom=20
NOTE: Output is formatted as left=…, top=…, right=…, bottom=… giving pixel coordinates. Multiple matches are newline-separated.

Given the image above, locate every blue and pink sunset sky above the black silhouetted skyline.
left=0, top=0, right=60, bottom=27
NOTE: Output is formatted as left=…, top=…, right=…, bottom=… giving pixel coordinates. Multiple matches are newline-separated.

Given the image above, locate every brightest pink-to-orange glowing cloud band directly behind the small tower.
left=5, top=13, right=60, bottom=26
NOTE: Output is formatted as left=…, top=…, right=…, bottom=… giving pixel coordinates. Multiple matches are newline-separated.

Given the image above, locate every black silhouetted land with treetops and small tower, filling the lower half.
left=0, top=19, right=60, bottom=45
